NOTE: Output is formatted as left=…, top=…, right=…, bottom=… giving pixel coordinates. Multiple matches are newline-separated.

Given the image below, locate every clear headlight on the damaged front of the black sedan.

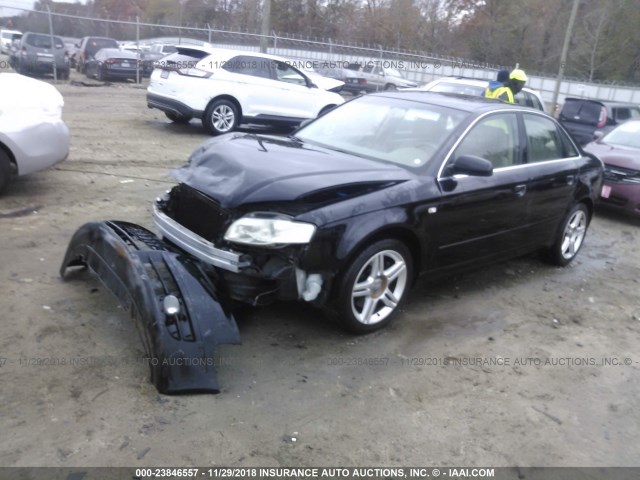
left=224, top=213, right=316, bottom=245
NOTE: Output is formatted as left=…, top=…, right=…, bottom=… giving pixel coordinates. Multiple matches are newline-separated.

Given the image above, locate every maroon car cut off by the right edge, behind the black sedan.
left=584, top=120, right=640, bottom=216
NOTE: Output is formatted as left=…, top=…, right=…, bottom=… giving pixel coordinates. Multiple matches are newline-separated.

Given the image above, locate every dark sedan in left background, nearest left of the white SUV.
left=84, top=48, right=143, bottom=81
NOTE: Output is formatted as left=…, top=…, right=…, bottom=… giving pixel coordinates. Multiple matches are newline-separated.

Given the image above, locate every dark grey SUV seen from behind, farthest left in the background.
left=11, top=32, right=70, bottom=79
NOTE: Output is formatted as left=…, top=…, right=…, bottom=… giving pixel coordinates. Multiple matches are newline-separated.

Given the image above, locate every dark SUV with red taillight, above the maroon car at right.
left=558, top=98, right=640, bottom=145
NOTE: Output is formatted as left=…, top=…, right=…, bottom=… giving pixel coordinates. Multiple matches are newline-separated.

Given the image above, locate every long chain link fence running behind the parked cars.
left=0, top=4, right=640, bottom=106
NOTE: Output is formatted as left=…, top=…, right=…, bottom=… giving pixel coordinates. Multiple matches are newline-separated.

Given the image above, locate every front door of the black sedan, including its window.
left=436, top=112, right=529, bottom=267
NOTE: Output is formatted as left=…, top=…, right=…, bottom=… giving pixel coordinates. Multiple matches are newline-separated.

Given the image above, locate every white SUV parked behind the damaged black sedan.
left=147, top=45, right=344, bottom=135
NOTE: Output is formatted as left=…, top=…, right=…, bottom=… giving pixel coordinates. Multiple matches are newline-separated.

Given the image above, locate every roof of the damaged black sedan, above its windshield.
left=369, top=90, right=541, bottom=113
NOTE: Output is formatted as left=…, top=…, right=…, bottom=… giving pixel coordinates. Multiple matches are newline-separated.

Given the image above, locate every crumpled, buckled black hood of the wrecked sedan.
left=172, top=133, right=415, bottom=208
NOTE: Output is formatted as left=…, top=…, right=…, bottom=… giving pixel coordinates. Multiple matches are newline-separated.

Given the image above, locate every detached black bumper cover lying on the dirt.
left=60, top=221, right=240, bottom=394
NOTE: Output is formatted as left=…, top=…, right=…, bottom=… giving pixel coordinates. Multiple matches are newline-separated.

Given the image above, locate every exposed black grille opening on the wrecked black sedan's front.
left=163, top=184, right=232, bottom=244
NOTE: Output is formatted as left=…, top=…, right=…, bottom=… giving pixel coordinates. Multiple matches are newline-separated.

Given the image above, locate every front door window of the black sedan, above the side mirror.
left=453, top=113, right=518, bottom=168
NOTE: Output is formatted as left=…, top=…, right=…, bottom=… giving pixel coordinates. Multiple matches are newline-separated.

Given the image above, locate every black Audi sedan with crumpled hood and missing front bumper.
left=153, top=92, right=603, bottom=333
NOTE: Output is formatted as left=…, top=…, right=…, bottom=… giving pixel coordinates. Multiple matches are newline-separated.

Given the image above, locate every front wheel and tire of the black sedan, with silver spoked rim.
left=331, top=239, right=413, bottom=334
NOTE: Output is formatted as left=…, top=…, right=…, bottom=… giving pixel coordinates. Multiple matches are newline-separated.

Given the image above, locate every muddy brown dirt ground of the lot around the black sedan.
left=0, top=68, right=640, bottom=466
